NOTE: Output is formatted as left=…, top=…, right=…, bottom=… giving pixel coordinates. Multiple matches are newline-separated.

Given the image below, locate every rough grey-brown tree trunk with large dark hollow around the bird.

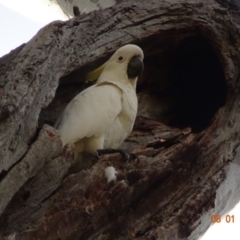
left=0, top=0, right=240, bottom=240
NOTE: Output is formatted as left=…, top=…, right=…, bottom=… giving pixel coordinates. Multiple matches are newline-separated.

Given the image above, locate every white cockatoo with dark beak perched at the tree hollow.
left=55, top=44, right=143, bottom=169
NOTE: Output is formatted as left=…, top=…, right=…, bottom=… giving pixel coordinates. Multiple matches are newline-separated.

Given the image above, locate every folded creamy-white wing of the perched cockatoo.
left=55, top=83, right=122, bottom=145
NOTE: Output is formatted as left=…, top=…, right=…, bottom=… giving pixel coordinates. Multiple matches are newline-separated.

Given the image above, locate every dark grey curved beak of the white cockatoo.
left=127, top=56, right=144, bottom=79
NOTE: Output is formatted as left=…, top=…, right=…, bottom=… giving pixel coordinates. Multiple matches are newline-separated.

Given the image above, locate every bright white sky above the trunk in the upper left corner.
left=0, top=0, right=66, bottom=57
